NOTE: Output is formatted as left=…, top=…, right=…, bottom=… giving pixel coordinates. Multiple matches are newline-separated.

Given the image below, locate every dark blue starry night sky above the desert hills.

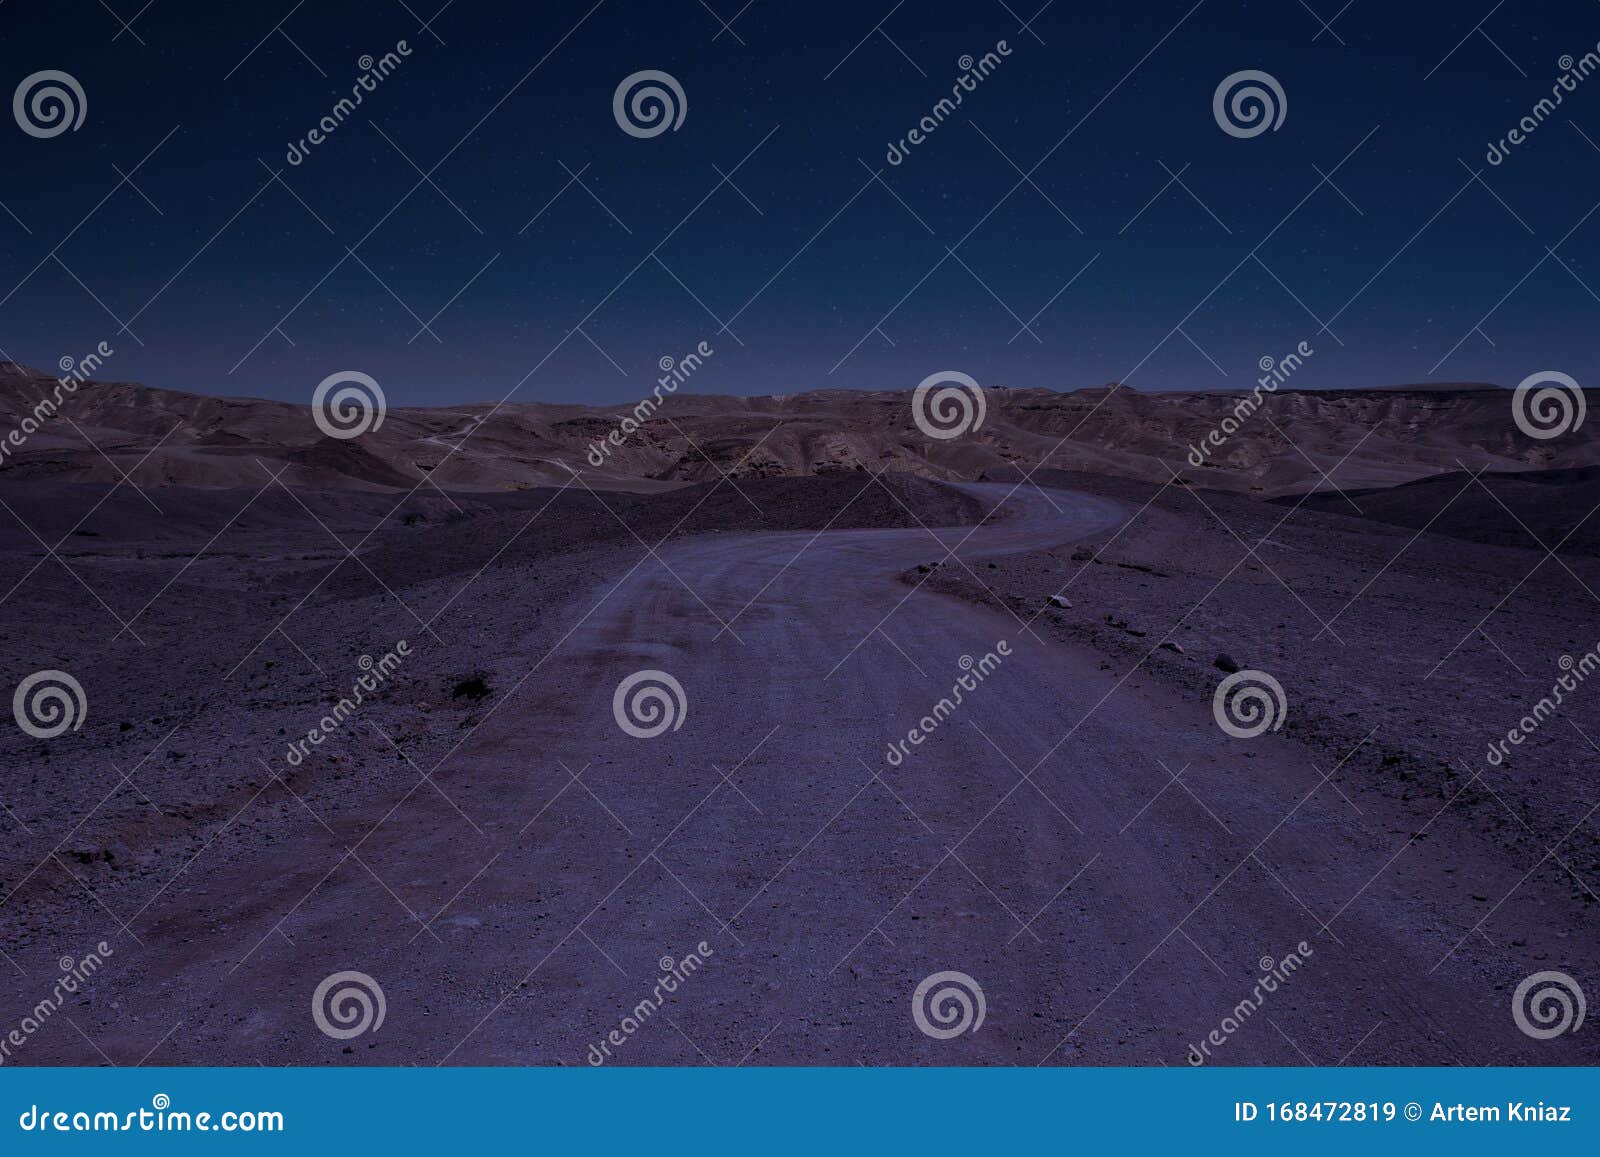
left=0, top=0, right=1600, bottom=405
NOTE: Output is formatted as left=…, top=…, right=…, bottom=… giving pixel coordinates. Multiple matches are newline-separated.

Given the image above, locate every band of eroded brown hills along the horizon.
left=0, top=362, right=1600, bottom=496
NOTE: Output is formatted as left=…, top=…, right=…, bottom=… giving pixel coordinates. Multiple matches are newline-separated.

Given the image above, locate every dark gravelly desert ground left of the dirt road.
left=0, top=478, right=981, bottom=966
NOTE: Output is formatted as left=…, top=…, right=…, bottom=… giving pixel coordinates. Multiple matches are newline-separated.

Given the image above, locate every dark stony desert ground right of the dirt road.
left=902, top=474, right=1600, bottom=1049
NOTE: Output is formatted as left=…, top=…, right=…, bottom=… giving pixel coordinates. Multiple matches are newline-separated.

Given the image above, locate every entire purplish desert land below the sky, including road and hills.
left=0, top=366, right=1600, bottom=1066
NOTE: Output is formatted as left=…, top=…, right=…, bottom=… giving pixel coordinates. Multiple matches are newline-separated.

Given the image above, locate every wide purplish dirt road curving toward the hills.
left=72, top=486, right=1578, bottom=1064
